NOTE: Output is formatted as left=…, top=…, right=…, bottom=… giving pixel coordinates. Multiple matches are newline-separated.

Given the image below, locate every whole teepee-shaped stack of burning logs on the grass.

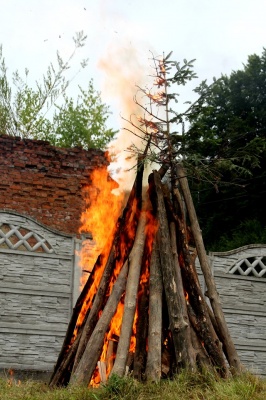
left=50, top=165, right=241, bottom=386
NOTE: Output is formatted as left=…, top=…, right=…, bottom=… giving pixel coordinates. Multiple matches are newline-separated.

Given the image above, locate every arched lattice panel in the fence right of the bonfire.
left=229, top=256, right=266, bottom=278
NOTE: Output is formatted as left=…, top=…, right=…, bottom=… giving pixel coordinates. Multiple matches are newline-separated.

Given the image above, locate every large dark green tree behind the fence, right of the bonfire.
left=184, top=49, right=266, bottom=250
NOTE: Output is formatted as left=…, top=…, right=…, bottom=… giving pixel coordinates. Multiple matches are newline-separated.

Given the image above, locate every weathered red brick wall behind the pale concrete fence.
left=0, top=135, right=108, bottom=234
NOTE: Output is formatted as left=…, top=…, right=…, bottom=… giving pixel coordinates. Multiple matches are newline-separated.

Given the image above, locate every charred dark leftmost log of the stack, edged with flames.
left=50, top=157, right=143, bottom=385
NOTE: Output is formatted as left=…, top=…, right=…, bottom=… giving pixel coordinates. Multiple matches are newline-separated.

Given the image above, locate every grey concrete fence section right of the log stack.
left=196, top=244, right=266, bottom=376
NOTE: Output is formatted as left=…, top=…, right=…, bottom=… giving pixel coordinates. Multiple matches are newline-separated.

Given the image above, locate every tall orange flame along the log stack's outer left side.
left=73, top=167, right=123, bottom=338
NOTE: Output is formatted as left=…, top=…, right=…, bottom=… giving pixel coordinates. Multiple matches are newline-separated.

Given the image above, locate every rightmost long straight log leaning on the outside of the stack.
left=177, top=164, right=243, bottom=373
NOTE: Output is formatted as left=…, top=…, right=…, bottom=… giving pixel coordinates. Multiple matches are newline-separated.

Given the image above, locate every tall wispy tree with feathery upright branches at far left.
left=0, top=31, right=88, bottom=138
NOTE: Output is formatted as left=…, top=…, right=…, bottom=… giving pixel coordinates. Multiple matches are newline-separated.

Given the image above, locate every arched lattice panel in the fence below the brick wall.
left=0, top=223, right=54, bottom=254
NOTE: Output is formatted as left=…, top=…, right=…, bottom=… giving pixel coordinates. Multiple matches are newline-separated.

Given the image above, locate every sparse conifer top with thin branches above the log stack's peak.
left=124, top=52, right=200, bottom=165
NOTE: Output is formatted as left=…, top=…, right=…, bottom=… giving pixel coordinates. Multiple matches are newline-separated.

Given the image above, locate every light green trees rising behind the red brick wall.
left=0, top=32, right=116, bottom=148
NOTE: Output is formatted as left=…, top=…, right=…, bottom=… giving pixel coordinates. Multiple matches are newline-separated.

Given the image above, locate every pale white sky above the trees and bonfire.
left=0, top=0, right=266, bottom=189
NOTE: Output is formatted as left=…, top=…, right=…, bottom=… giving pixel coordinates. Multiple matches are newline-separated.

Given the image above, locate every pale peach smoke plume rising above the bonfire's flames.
left=99, top=42, right=154, bottom=195
